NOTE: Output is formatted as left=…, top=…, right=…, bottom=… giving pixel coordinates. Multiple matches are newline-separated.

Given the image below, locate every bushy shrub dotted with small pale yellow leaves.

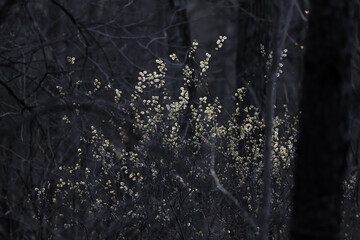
left=34, top=36, right=297, bottom=239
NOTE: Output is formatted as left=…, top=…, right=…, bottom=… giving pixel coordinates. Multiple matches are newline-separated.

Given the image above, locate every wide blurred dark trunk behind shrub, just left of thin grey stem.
left=236, top=0, right=273, bottom=107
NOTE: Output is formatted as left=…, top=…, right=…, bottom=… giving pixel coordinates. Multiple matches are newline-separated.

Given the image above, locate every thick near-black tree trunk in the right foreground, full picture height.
left=290, top=0, right=353, bottom=240
